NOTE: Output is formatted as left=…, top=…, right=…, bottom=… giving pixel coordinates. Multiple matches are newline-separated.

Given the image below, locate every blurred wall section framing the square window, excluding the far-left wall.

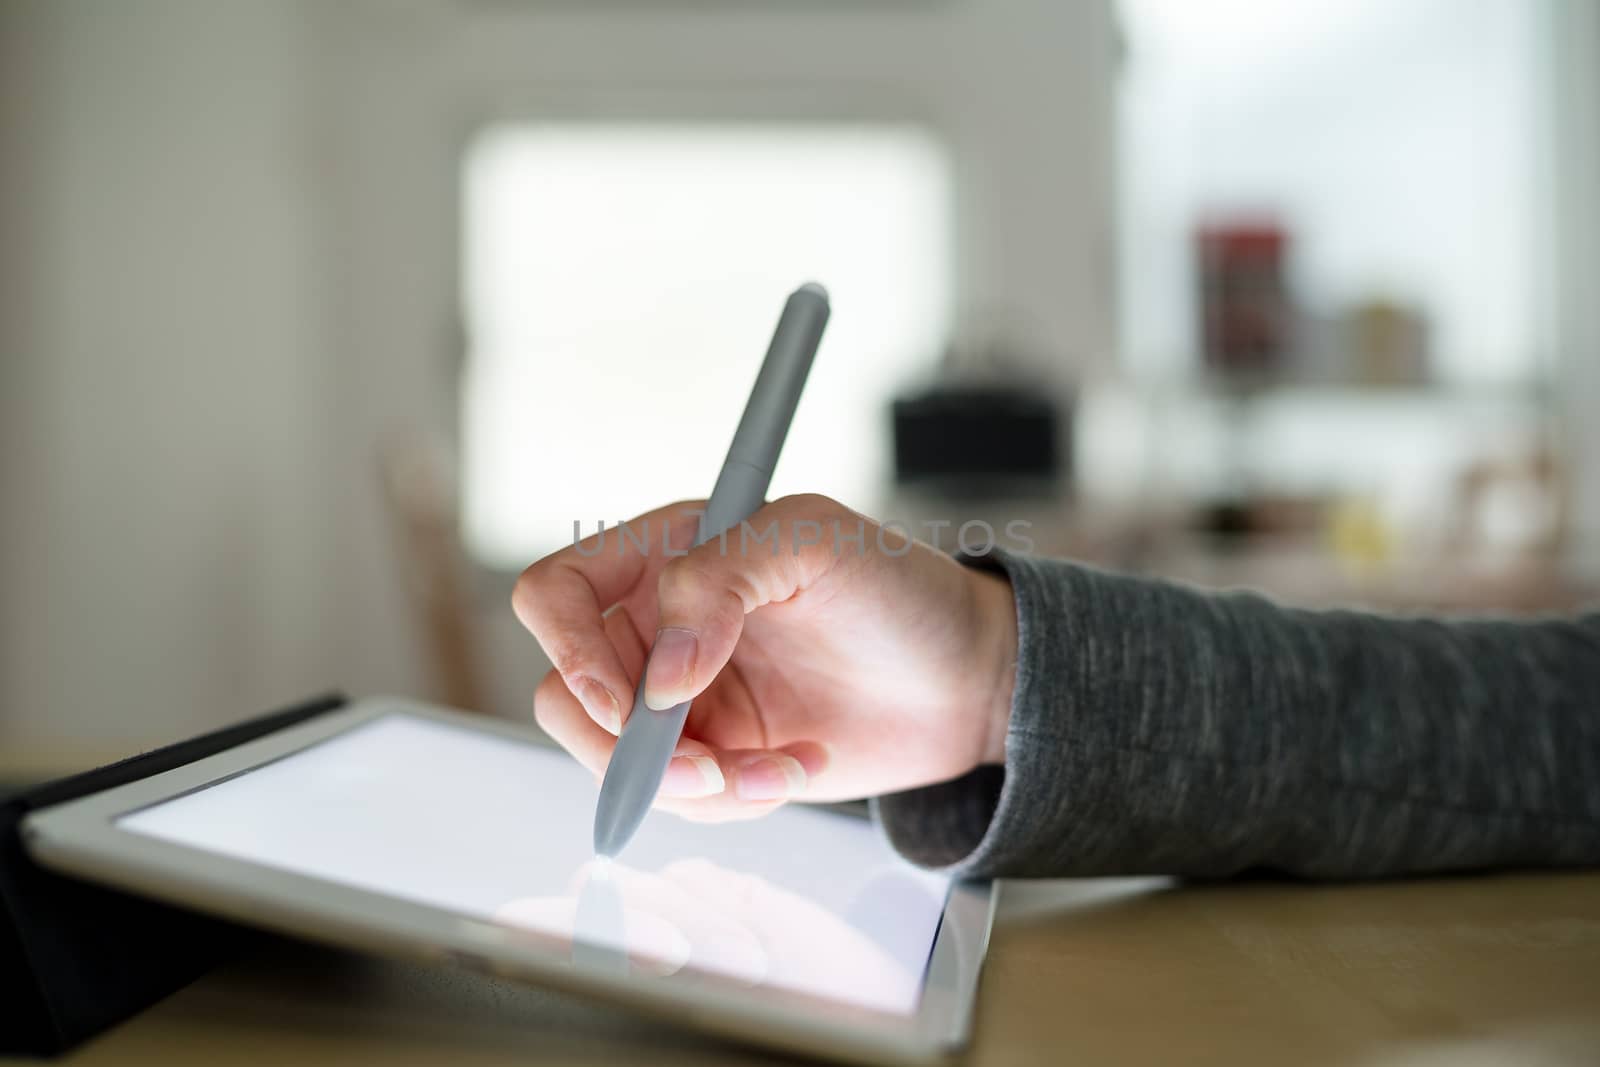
left=317, top=0, right=1115, bottom=726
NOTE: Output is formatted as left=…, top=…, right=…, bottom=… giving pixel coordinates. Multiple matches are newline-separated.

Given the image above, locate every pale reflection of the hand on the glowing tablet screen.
left=496, top=859, right=920, bottom=1011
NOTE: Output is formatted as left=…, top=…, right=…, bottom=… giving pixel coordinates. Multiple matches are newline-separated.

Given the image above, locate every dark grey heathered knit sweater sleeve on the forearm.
left=875, top=555, right=1600, bottom=878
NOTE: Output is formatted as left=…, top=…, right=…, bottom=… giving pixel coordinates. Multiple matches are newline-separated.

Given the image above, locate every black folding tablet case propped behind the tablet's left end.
left=0, top=694, right=346, bottom=1056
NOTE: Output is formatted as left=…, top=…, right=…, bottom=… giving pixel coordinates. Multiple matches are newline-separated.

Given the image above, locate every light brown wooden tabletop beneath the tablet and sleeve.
left=12, top=873, right=1600, bottom=1067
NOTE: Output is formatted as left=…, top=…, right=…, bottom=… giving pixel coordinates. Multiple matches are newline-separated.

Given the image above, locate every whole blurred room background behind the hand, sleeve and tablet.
left=0, top=0, right=1600, bottom=763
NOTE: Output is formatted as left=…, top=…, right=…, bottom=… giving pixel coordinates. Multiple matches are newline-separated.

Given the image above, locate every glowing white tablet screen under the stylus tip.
left=117, top=713, right=949, bottom=1014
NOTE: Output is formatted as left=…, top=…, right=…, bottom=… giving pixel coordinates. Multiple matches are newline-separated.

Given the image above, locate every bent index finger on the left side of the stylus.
left=510, top=502, right=701, bottom=733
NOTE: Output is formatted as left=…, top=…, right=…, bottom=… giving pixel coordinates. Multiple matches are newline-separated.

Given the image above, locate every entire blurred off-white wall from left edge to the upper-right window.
left=0, top=0, right=1112, bottom=749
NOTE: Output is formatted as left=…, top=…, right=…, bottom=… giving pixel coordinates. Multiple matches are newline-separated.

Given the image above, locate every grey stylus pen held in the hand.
left=595, top=282, right=829, bottom=856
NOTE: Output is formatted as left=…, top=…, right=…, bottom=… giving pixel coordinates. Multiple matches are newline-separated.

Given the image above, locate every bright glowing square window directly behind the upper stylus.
left=462, top=123, right=952, bottom=566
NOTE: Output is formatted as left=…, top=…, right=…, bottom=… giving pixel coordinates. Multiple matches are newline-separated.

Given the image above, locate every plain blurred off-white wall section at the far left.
left=0, top=0, right=352, bottom=744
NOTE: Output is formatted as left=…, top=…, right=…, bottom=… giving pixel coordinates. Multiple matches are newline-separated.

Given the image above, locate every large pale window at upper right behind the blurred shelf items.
left=1118, top=0, right=1549, bottom=386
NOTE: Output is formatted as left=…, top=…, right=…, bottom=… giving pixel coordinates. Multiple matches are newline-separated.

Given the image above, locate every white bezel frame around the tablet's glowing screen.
left=22, top=699, right=995, bottom=1064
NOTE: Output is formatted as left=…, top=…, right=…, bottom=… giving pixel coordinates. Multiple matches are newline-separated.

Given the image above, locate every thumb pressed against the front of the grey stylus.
left=645, top=496, right=858, bottom=710
